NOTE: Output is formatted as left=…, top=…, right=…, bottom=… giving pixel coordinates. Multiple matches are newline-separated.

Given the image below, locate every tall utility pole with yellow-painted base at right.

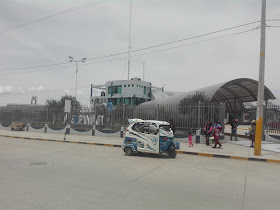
left=254, top=0, right=266, bottom=155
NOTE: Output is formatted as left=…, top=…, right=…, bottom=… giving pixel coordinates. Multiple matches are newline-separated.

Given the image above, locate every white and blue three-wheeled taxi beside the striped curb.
left=122, top=119, right=180, bottom=158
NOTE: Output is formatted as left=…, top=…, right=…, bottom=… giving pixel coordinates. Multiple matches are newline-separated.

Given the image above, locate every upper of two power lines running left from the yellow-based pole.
left=0, top=21, right=260, bottom=71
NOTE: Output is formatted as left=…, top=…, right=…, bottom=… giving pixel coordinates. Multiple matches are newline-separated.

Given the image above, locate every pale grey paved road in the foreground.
left=0, top=138, right=280, bottom=210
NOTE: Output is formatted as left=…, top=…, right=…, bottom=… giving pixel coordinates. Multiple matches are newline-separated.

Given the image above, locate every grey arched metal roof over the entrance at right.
left=141, top=78, right=276, bottom=112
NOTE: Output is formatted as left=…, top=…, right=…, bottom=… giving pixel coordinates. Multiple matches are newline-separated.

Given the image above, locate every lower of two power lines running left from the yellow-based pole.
left=0, top=27, right=259, bottom=75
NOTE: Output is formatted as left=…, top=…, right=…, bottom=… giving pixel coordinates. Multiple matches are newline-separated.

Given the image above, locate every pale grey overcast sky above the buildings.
left=0, top=0, right=280, bottom=105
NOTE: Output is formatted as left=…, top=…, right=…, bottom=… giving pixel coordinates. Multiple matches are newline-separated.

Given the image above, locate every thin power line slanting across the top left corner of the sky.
left=0, top=0, right=111, bottom=33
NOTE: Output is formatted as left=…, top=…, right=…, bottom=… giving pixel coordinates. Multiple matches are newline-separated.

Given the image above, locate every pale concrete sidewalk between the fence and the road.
left=0, top=130, right=280, bottom=163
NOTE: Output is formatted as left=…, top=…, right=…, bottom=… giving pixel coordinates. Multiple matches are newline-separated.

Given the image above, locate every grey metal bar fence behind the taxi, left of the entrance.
left=0, top=103, right=225, bottom=133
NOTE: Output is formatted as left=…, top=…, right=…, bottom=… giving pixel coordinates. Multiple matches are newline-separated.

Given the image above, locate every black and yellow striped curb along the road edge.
left=0, top=135, right=280, bottom=163
